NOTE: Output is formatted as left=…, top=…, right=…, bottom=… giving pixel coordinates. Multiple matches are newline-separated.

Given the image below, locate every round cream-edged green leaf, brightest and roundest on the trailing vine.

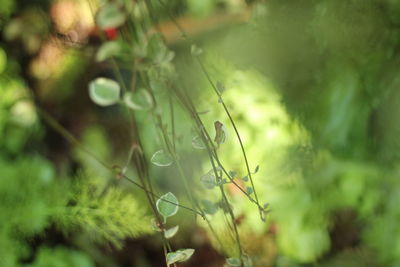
left=89, top=78, right=120, bottom=106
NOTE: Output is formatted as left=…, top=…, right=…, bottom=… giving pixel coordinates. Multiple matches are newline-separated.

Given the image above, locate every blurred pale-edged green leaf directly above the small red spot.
left=96, top=2, right=126, bottom=29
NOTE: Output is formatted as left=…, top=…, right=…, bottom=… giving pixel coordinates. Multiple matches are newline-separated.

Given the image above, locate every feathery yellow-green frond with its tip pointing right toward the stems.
left=55, top=176, right=152, bottom=248
